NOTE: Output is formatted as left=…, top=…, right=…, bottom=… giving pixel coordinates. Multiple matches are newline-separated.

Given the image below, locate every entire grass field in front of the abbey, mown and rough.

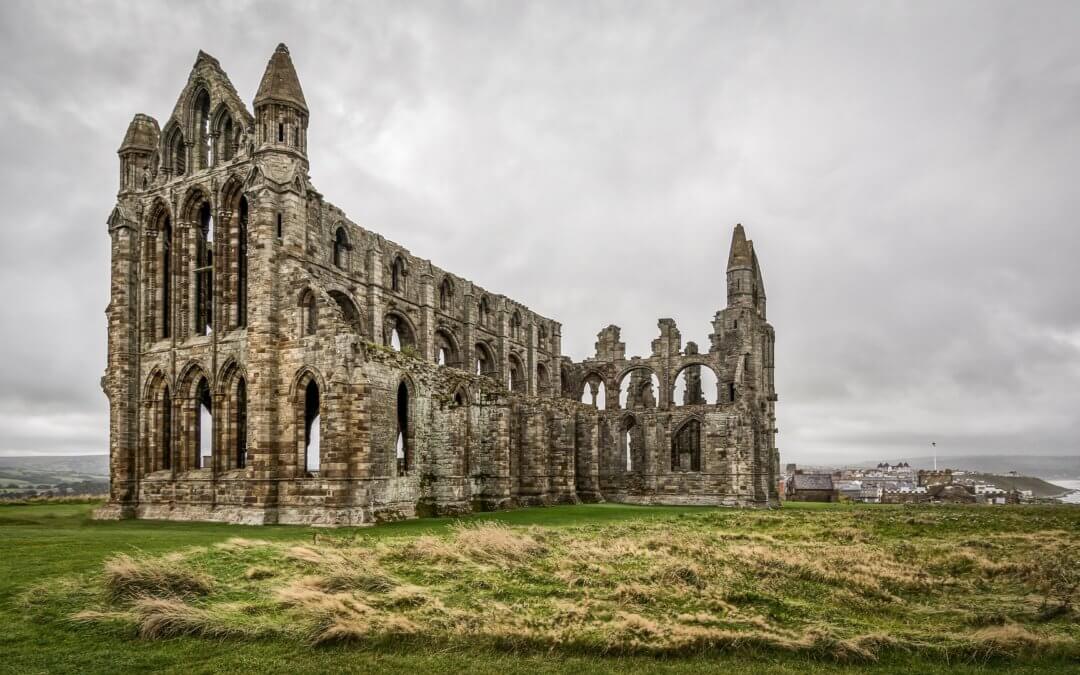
left=0, top=496, right=1080, bottom=673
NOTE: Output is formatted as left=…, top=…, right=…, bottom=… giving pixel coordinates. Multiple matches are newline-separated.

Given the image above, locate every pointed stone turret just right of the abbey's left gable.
left=255, top=44, right=308, bottom=162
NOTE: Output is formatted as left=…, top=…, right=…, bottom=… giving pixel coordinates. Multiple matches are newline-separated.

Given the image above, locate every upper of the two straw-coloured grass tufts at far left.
left=105, top=554, right=214, bottom=600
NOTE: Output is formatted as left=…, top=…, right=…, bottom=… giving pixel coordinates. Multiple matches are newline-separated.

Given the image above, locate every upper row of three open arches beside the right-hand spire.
left=578, top=363, right=735, bottom=410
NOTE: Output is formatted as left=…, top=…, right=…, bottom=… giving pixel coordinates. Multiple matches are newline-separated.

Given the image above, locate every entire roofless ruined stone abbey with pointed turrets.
left=97, top=45, right=779, bottom=525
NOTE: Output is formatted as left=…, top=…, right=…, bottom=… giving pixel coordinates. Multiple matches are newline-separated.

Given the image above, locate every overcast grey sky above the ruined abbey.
left=0, top=0, right=1080, bottom=462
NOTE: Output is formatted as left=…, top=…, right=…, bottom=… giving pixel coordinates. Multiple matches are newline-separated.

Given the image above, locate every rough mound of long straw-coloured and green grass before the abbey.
left=33, top=508, right=1080, bottom=663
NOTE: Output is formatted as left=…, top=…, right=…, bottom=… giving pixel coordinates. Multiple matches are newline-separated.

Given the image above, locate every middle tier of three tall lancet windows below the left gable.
left=144, top=181, right=251, bottom=340
